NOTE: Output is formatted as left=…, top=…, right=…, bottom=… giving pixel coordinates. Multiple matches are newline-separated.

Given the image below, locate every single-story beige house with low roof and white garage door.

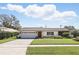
left=20, top=27, right=69, bottom=38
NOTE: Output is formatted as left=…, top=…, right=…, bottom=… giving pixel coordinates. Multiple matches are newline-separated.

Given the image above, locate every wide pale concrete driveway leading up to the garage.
left=0, top=39, right=33, bottom=55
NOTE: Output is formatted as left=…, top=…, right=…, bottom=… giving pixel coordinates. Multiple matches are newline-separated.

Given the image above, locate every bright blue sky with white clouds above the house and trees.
left=0, top=3, right=79, bottom=28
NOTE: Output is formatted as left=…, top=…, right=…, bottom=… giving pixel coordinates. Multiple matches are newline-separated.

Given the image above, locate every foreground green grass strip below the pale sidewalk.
left=26, top=46, right=79, bottom=55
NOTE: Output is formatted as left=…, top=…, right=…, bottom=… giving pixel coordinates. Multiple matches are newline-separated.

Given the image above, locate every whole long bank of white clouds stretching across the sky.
left=1, top=4, right=77, bottom=20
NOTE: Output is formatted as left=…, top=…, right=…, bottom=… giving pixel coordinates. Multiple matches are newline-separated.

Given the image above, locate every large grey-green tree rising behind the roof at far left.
left=0, top=14, right=21, bottom=29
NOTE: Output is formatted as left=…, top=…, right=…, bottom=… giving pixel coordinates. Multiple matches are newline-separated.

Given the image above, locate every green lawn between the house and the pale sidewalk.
left=31, top=38, right=79, bottom=45
